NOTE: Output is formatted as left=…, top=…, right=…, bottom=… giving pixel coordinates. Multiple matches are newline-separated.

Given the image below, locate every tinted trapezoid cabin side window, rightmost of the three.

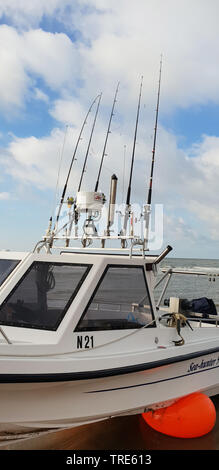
left=76, top=265, right=155, bottom=331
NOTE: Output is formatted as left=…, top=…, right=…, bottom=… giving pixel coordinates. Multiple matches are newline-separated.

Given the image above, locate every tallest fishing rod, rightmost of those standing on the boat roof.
left=144, top=55, right=162, bottom=250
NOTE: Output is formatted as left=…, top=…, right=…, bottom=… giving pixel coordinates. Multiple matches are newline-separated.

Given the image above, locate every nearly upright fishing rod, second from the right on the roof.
left=121, top=76, right=143, bottom=248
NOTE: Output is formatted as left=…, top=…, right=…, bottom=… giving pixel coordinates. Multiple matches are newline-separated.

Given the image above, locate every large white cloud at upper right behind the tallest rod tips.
left=60, top=0, right=219, bottom=111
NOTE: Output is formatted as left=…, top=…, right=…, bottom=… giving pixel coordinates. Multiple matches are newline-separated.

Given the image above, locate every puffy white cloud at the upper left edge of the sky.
left=0, top=25, right=79, bottom=111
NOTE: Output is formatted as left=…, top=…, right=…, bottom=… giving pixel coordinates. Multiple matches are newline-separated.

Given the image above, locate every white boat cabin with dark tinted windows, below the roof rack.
left=0, top=252, right=156, bottom=346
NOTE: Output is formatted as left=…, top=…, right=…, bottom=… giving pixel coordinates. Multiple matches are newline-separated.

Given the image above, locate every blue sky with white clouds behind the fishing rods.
left=0, top=0, right=219, bottom=258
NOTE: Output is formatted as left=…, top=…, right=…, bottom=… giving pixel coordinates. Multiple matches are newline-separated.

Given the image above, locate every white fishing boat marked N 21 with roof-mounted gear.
left=0, top=61, right=219, bottom=432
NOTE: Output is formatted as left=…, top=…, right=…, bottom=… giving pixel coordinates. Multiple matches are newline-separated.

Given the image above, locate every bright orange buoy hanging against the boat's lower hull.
left=142, top=392, right=216, bottom=438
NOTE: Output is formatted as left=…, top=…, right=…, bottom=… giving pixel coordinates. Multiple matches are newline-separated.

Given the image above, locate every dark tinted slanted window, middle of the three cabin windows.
left=0, top=262, right=91, bottom=330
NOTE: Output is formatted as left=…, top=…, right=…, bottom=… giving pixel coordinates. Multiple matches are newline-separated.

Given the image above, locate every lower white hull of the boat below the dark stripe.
left=0, top=352, right=219, bottom=432
